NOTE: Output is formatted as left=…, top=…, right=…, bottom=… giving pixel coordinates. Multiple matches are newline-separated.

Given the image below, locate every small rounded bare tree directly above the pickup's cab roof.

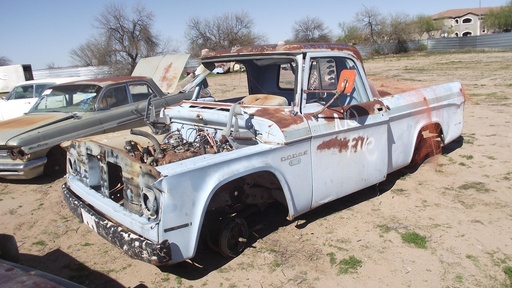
left=292, top=16, right=332, bottom=43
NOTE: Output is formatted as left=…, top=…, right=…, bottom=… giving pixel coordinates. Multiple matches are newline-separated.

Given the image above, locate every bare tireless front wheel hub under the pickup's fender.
left=219, top=218, right=249, bottom=258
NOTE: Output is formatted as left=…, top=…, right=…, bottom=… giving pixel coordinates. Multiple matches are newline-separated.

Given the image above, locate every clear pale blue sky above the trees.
left=0, top=0, right=508, bottom=70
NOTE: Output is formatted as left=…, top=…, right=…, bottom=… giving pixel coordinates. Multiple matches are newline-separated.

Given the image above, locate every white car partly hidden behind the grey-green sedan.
left=0, top=77, right=84, bottom=121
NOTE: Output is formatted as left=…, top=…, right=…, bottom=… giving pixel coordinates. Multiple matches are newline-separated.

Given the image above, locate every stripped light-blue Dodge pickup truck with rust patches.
left=62, top=43, right=465, bottom=265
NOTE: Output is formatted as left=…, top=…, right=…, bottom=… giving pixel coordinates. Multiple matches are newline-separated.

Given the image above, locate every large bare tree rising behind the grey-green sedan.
left=71, top=3, right=166, bottom=75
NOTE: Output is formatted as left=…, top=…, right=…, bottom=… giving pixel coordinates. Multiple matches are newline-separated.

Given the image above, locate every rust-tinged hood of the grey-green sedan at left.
left=0, top=112, right=83, bottom=145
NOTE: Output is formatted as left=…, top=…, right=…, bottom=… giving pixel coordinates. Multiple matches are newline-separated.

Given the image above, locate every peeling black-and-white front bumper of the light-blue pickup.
left=62, top=184, right=172, bottom=266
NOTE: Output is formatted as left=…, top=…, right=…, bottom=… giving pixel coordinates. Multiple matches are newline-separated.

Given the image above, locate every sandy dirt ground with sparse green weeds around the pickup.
left=0, top=52, right=512, bottom=287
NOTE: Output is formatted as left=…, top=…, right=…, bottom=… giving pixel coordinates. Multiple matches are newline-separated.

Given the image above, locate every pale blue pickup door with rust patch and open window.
left=302, top=52, right=389, bottom=208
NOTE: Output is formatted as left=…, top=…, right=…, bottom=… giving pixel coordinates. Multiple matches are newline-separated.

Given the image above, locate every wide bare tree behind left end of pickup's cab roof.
left=185, top=11, right=266, bottom=56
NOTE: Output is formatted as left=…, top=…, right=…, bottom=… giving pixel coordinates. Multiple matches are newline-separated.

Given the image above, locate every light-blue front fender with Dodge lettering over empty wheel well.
left=155, top=143, right=312, bottom=261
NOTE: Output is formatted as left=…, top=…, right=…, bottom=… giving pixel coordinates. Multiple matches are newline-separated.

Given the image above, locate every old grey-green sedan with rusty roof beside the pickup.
left=0, top=76, right=192, bottom=179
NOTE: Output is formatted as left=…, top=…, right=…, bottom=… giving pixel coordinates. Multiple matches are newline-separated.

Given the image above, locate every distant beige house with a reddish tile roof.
left=431, top=7, right=500, bottom=37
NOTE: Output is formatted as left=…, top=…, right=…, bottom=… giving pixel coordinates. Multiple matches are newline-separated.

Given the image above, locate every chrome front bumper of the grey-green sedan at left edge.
left=0, top=157, right=47, bottom=179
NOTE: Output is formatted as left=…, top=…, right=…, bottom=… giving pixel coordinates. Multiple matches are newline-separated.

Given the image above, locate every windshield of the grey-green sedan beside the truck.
left=28, top=84, right=101, bottom=113
